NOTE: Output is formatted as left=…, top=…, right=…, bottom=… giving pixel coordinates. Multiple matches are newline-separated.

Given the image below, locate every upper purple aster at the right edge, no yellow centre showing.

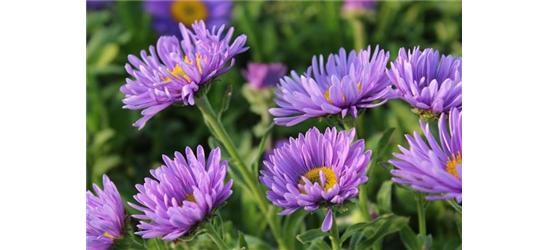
left=387, top=47, right=460, bottom=114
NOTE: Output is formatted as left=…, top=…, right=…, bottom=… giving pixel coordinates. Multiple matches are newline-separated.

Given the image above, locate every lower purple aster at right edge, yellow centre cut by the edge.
left=389, top=108, right=465, bottom=202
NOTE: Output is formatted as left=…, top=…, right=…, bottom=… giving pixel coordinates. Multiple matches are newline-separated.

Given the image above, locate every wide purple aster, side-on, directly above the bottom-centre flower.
left=269, top=47, right=392, bottom=126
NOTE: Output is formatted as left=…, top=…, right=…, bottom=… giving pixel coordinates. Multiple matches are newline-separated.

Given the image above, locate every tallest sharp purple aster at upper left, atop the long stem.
left=120, top=21, right=248, bottom=129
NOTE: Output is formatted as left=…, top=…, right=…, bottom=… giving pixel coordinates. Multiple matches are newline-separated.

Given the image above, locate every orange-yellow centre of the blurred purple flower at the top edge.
left=171, top=0, right=208, bottom=27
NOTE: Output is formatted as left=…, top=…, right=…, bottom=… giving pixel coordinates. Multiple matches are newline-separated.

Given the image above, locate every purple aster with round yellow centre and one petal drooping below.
left=260, top=128, right=372, bottom=232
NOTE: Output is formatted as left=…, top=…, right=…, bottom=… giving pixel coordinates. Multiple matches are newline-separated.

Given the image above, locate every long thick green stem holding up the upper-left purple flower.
left=195, top=94, right=286, bottom=249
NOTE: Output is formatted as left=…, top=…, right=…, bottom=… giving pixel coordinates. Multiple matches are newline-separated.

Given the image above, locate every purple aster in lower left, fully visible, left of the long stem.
left=129, top=146, right=233, bottom=241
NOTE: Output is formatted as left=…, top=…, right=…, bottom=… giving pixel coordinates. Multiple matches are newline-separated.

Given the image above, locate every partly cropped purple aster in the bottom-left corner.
left=86, top=175, right=124, bottom=250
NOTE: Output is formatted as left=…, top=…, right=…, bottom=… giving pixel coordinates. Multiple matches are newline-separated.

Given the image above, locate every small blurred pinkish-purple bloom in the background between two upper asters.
left=242, top=63, right=288, bottom=90
